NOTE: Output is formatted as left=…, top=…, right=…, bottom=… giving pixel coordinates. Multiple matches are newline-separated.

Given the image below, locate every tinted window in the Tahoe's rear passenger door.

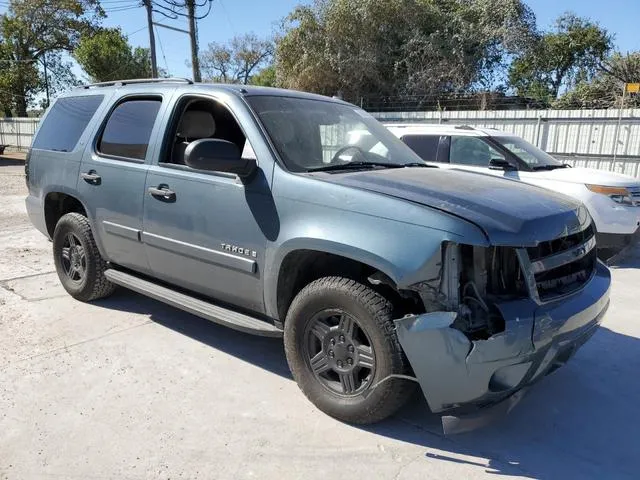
left=98, top=98, right=161, bottom=160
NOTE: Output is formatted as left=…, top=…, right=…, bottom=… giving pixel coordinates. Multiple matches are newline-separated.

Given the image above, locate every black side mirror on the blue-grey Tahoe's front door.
left=184, top=138, right=258, bottom=178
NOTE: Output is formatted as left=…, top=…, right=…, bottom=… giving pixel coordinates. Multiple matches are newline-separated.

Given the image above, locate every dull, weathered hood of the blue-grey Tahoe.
left=313, top=168, right=591, bottom=247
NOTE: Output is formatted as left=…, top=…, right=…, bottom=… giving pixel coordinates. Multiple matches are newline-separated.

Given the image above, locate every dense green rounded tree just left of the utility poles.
left=73, top=28, right=152, bottom=82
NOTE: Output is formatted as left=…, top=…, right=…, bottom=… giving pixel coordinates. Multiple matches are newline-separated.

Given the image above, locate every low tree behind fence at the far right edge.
left=553, top=52, right=640, bottom=108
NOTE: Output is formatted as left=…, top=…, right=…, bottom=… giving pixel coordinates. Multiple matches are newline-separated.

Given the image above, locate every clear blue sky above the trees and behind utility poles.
left=0, top=0, right=640, bottom=81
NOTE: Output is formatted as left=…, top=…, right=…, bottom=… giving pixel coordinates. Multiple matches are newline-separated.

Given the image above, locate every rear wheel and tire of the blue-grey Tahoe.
left=53, top=213, right=115, bottom=302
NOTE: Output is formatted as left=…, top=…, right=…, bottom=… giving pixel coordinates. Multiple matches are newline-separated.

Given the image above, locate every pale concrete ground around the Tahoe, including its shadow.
left=0, top=160, right=640, bottom=480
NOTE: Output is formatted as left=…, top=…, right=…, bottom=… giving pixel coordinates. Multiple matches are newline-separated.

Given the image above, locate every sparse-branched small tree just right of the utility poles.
left=200, top=33, right=273, bottom=84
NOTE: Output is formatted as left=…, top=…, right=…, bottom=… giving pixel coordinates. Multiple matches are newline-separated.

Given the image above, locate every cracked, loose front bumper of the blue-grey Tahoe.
left=395, top=262, right=611, bottom=433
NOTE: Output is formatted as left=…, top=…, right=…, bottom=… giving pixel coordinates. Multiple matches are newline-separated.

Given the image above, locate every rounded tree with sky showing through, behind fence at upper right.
left=509, top=13, right=612, bottom=101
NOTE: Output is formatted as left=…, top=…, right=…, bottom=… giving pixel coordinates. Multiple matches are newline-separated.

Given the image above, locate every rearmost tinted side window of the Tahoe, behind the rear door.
left=31, top=95, right=104, bottom=152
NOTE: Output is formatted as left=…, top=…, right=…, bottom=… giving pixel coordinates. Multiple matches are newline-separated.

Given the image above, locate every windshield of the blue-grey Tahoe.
left=247, top=95, right=426, bottom=172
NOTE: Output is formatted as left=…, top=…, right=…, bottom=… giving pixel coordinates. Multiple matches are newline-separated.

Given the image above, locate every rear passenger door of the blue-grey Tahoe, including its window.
left=78, top=89, right=168, bottom=272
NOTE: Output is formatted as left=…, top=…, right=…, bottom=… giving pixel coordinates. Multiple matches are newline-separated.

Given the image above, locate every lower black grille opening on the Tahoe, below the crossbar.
left=535, top=248, right=597, bottom=300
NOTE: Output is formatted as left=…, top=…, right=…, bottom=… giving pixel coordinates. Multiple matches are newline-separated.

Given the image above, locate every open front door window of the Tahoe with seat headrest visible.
left=165, top=99, right=255, bottom=165
